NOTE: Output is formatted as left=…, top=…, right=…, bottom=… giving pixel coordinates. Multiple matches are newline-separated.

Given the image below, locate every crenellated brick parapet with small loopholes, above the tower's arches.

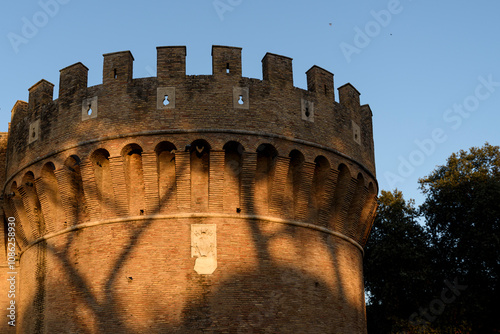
left=5, top=45, right=375, bottom=183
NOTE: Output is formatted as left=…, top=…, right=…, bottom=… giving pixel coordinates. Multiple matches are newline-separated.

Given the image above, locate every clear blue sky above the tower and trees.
left=0, top=0, right=500, bottom=204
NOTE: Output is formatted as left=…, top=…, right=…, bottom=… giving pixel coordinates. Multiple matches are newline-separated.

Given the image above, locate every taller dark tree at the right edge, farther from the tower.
left=419, top=143, right=500, bottom=333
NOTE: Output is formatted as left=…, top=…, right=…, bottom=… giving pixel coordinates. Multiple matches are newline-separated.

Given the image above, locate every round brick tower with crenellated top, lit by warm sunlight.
left=0, top=46, right=378, bottom=334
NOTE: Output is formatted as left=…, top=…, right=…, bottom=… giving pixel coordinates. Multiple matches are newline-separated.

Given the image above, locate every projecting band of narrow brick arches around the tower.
left=8, top=139, right=376, bottom=250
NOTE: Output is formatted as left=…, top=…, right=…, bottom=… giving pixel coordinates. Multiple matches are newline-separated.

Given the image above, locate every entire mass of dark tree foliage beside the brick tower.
left=365, top=143, right=500, bottom=333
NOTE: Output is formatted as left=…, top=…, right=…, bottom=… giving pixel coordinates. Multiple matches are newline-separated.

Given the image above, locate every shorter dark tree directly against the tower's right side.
left=364, top=190, right=432, bottom=333
